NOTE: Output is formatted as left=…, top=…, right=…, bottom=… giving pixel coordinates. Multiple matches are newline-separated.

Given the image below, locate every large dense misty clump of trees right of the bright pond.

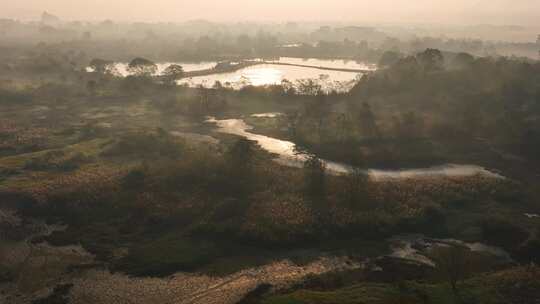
left=276, top=49, right=540, bottom=166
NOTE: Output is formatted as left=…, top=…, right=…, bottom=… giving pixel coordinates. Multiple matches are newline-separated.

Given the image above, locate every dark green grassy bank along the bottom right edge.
left=259, top=267, right=540, bottom=304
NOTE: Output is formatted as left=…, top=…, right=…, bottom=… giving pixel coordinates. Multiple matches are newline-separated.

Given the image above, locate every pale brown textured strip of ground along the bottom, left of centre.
left=70, top=257, right=362, bottom=304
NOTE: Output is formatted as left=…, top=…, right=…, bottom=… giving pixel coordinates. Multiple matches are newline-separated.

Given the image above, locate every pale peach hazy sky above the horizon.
left=0, top=0, right=540, bottom=25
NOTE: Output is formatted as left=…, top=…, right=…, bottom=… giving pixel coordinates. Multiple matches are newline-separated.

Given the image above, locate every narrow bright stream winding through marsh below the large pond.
left=207, top=113, right=504, bottom=180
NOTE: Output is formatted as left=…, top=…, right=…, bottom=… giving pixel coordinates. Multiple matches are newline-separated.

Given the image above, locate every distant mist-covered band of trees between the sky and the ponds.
left=0, top=19, right=540, bottom=66
